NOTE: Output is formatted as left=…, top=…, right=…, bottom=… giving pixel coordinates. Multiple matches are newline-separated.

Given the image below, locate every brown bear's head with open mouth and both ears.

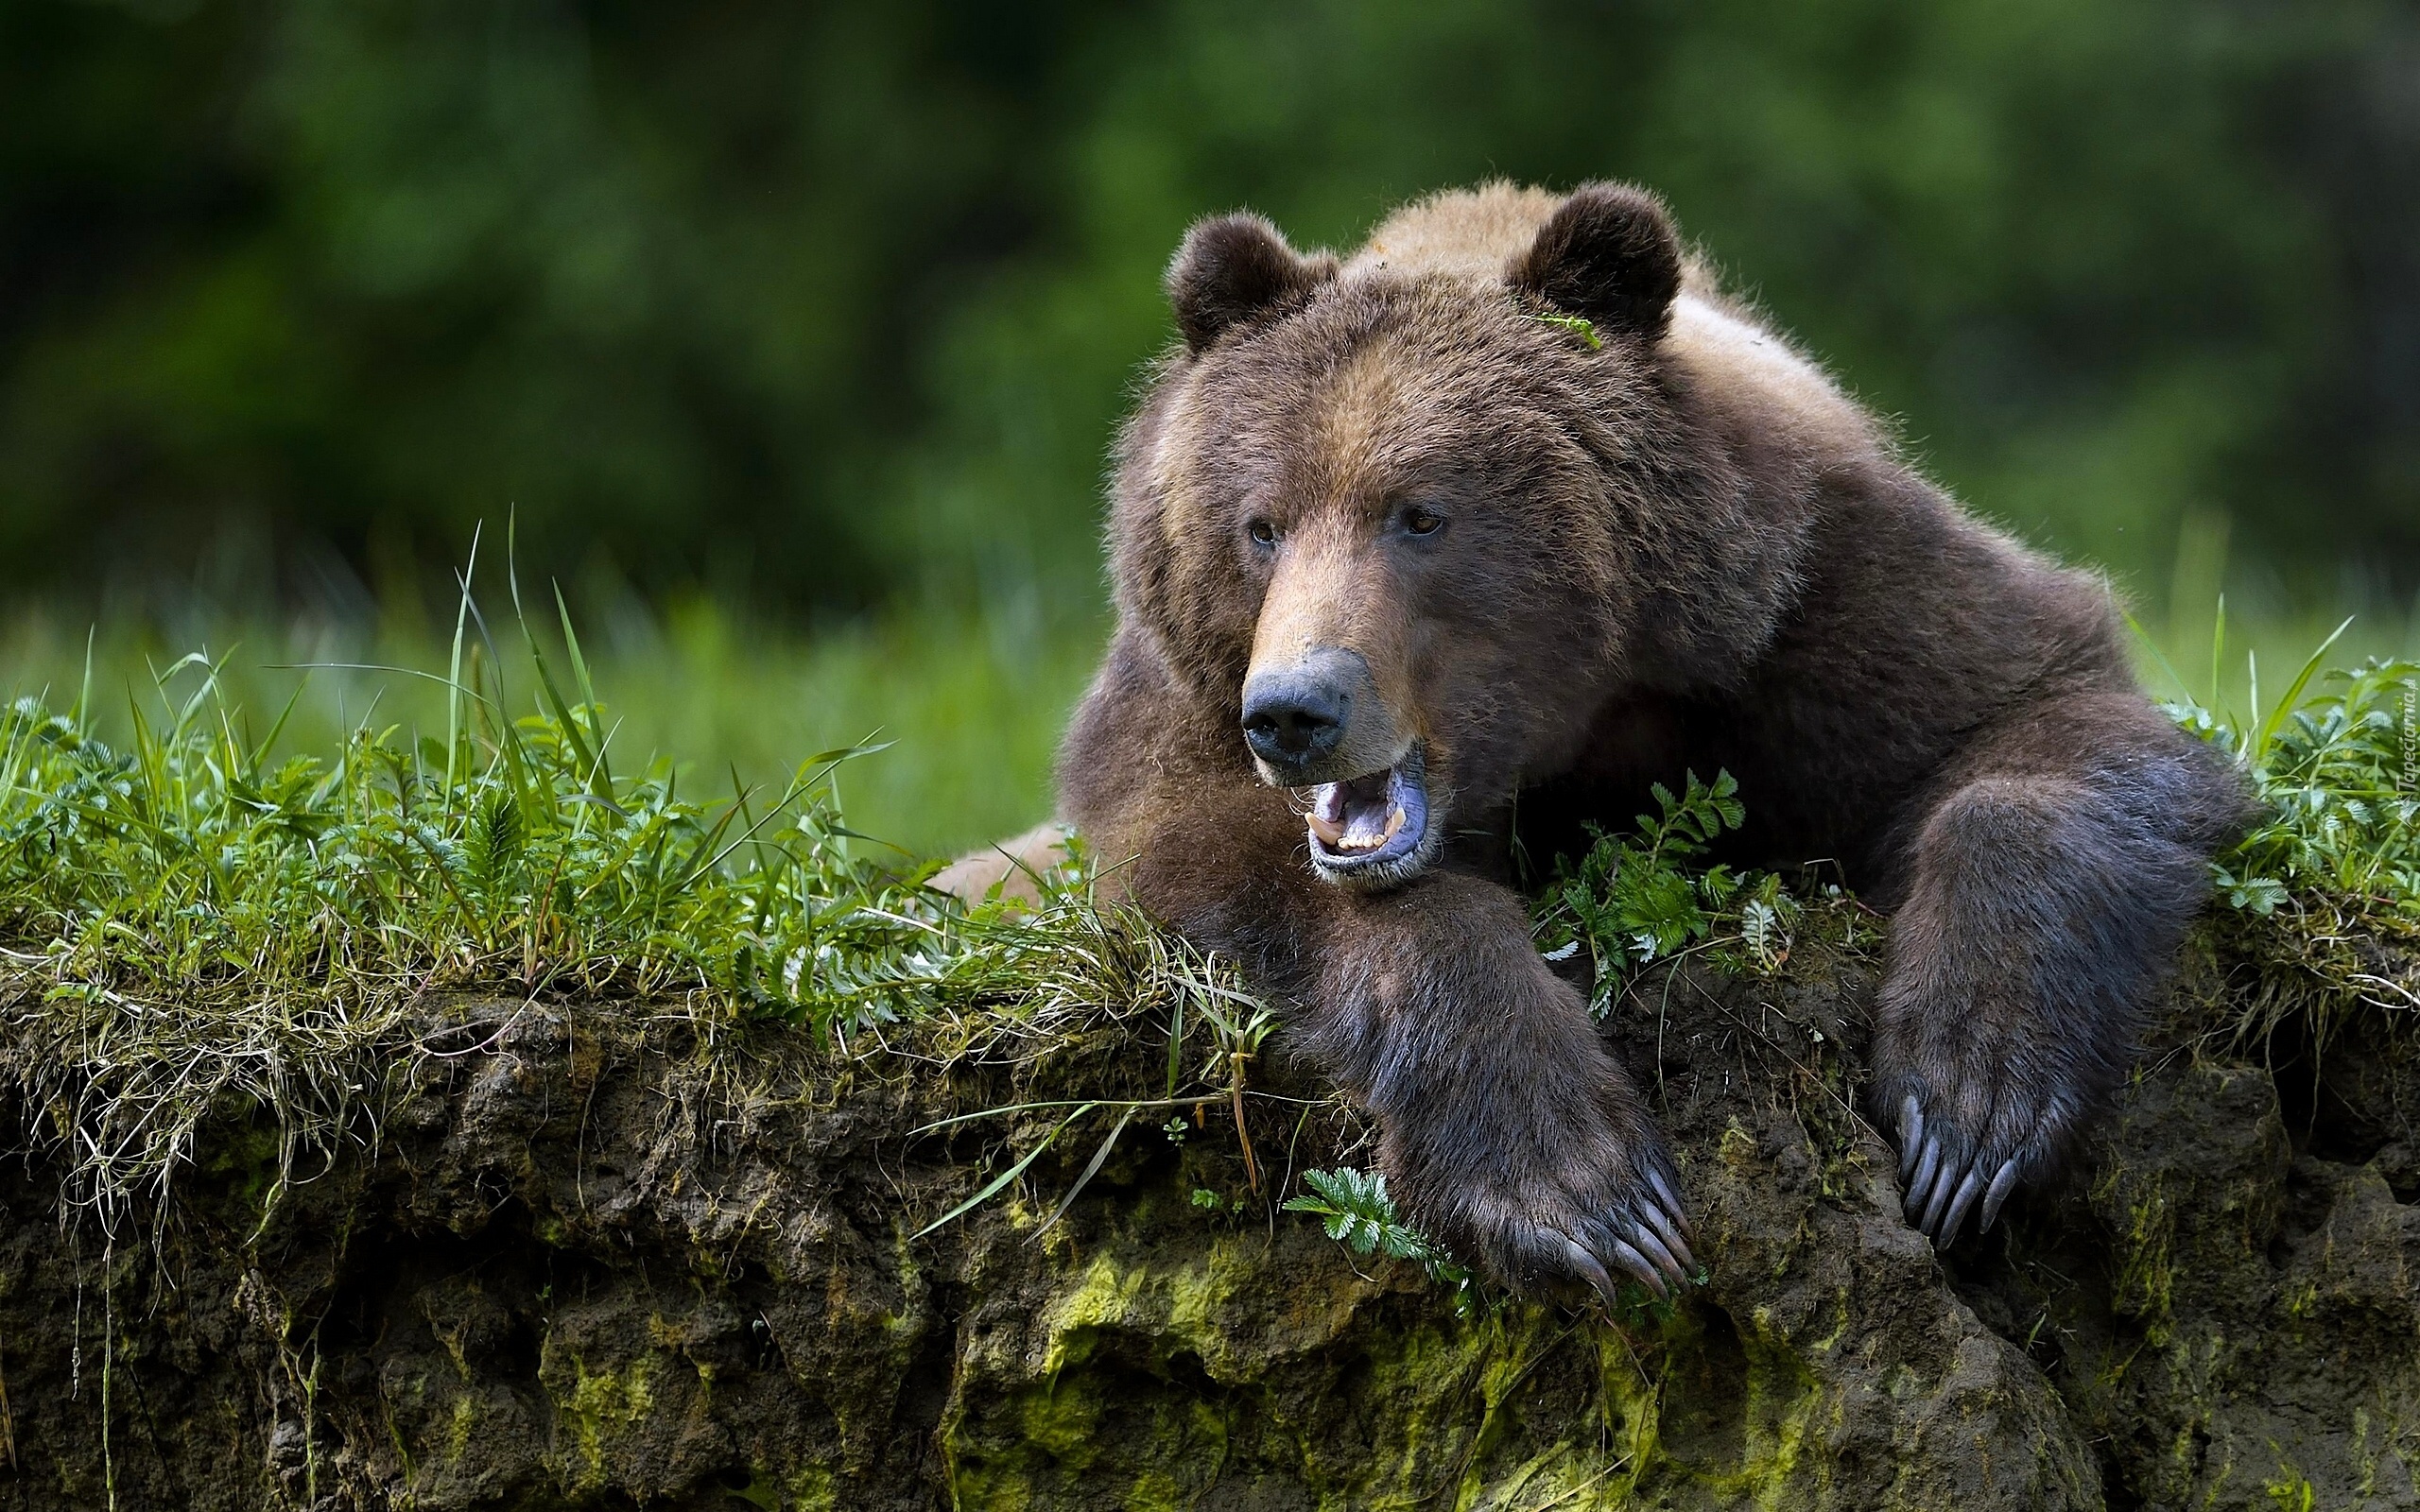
left=1111, top=184, right=1800, bottom=885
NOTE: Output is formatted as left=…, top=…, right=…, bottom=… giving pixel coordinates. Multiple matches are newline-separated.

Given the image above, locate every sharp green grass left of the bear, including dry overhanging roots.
left=0, top=582, right=1219, bottom=1222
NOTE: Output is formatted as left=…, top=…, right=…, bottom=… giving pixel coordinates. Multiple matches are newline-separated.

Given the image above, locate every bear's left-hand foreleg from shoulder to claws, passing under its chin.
left=1060, top=631, right=1694, bottom=1292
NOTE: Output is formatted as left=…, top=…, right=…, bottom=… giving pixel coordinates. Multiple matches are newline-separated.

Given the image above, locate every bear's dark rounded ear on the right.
left=1505, top=184, right=1680, bottom=338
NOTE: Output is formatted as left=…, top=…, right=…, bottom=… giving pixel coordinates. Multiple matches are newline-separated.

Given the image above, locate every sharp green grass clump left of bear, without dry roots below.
left=0, top=638, right=949, bottom=1028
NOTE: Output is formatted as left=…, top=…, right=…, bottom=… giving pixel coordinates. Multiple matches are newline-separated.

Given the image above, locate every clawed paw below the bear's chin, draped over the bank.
left=1389, top=1120, right=1697, bottom=1304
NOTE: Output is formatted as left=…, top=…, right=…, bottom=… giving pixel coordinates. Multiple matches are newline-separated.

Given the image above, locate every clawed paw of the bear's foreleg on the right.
left=1876, top=1031, right=2086, bottom=1248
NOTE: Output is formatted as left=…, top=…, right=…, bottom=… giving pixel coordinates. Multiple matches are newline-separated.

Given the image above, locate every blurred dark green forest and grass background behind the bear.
left=0, top=0, right=2420, bottom=851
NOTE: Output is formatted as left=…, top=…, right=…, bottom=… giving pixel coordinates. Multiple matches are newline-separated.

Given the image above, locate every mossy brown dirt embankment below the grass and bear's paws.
left=0, top=934, right=2420, bottom=1512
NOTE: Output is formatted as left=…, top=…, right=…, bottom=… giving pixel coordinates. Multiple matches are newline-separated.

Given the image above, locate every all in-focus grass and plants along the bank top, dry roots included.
left=0, top=582, right=2420, bottom=1233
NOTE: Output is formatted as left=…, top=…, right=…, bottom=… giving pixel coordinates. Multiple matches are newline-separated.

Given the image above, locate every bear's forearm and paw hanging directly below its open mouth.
left=1292, top=876, right=1694, bottom=1299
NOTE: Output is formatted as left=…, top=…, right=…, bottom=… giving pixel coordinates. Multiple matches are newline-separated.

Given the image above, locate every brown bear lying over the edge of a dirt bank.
left=959, top=184, right=2243, bottom=1292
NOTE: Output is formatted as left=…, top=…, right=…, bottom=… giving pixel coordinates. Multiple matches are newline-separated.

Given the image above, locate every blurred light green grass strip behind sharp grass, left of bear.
left=0, top=600, right=1106, bottom=856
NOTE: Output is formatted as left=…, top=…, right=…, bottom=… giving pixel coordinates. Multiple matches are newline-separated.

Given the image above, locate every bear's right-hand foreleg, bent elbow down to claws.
left=1873, top=699, right=2238, bottom=1246
